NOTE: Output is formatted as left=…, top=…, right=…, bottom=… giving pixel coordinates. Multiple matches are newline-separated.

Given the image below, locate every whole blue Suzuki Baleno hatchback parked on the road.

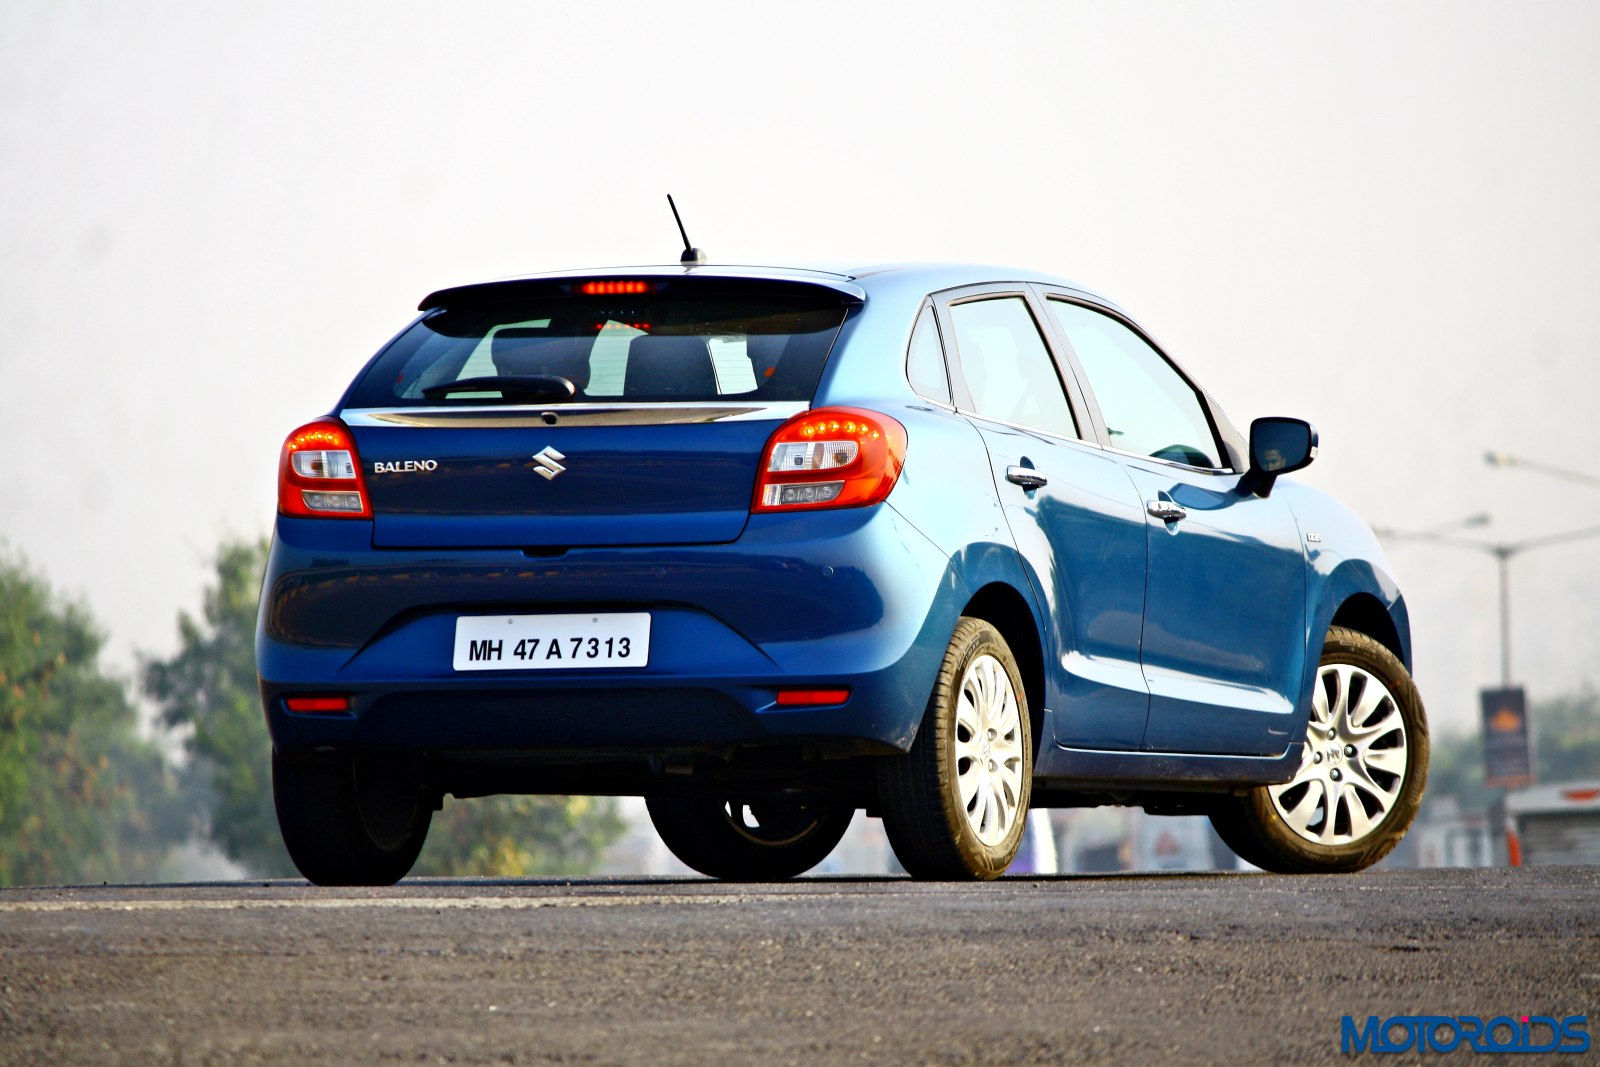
left=258, top=262, right=1429, bottom=885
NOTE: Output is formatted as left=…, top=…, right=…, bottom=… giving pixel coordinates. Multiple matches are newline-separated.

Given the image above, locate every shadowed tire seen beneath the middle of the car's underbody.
left=645, top=797, right=854, bottom=881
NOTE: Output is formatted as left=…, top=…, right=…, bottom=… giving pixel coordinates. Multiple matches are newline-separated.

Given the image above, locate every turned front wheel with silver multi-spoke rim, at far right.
left=1211, top=625, right=1429, bottom=873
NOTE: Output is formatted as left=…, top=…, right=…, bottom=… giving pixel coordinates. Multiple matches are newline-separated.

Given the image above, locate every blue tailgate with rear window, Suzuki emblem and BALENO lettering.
left=341, top=277, right=851, bottom=549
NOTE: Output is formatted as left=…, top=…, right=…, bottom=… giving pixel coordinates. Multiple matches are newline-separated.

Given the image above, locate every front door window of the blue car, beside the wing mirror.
left=1050, top=299, right=1221, bottom=467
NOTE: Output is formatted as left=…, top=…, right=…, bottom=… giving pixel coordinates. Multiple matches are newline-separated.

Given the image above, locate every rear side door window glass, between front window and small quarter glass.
left=950, top=296, right=1078, bottom=437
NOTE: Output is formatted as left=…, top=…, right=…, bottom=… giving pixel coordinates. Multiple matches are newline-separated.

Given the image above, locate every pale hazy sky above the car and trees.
left=0, top=0, right=1600, bottom=729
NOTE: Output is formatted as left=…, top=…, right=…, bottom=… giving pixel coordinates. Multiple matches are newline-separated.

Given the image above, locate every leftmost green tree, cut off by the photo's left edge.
left=0, top=557, right=184, bottom=885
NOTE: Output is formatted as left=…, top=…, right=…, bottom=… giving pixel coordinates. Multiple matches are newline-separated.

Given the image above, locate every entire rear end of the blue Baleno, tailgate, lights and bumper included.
left=258, top=269, right=947, bottom=795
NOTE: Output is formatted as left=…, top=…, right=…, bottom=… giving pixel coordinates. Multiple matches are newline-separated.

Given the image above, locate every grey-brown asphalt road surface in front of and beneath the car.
left=0, top=867, right=1600, bottom=1067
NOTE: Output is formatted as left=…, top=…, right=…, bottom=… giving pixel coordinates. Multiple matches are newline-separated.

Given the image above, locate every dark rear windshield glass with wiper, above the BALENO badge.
left=349, top=285, right=845, bottom=408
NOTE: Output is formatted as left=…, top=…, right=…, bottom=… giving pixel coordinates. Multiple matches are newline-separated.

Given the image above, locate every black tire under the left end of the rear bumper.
left=272, top=750, right=434, bottom=886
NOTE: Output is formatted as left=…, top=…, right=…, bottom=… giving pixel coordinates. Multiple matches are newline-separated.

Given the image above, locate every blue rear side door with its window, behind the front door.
left=938, top=286, right=1149, bottom=749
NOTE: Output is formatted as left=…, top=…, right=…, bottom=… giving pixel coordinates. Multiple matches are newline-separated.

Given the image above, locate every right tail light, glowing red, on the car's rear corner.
left=750, top=408, right=906, bottom=512
